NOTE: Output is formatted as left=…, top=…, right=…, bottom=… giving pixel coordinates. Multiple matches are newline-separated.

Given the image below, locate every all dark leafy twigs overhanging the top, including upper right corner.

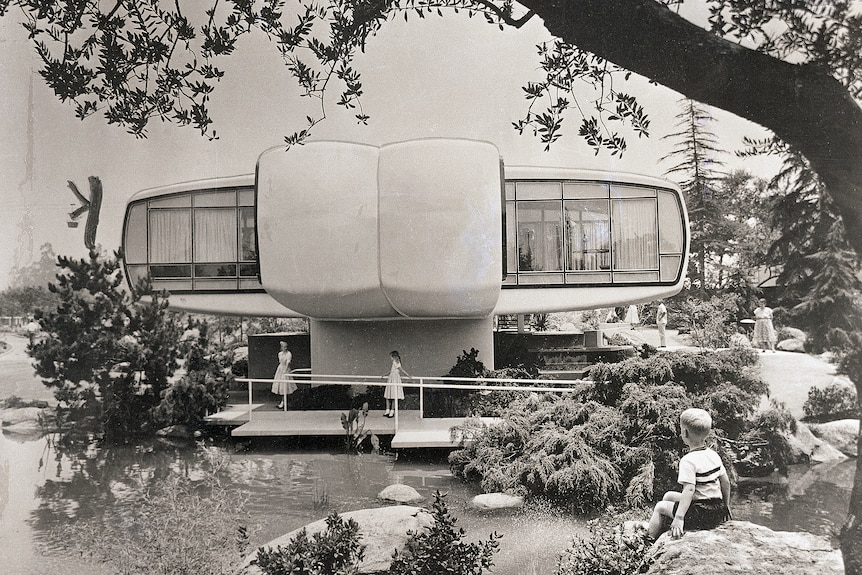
left=6, top=0, right=862, bottom=155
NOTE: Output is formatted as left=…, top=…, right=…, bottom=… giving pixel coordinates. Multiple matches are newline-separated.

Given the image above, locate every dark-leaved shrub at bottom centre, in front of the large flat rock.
left=387, top=491, right=500, bottom=575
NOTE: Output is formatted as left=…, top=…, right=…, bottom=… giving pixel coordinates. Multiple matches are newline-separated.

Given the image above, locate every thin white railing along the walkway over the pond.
left=236, top=369, right=592, bottom=431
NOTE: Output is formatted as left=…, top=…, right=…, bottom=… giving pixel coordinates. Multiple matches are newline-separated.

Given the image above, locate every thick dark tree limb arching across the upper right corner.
left=520, top=0, right=862, bottom=254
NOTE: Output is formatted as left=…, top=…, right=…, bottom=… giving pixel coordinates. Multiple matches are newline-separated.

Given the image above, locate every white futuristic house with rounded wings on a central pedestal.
left=123, top=139, right=688, bottom=375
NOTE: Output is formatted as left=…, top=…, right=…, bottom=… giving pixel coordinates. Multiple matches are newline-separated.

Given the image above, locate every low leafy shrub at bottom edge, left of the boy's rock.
left=554, top=530, right=654, bottom=575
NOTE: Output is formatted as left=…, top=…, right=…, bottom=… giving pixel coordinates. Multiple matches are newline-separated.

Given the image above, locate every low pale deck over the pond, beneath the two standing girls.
left=207, top=404, right=497, bottom=449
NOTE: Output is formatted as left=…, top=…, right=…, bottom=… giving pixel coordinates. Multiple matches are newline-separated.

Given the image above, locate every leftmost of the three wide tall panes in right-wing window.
left=517, top=201, right=563, bottom=272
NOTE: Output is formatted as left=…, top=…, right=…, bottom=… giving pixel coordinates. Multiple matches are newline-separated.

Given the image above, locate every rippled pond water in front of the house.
left=0, top=434, right=855, bottom=575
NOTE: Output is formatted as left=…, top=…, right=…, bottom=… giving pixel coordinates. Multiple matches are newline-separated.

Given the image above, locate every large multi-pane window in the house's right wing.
left=504, top=181, right=684, bottom=285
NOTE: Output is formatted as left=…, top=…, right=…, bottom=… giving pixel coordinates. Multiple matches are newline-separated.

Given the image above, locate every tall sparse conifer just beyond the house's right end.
left=662, top=100, right=729, bottom=287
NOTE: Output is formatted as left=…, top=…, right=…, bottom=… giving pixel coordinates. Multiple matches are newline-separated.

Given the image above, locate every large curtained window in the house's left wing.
left=124, top=188, right=261, bottom=292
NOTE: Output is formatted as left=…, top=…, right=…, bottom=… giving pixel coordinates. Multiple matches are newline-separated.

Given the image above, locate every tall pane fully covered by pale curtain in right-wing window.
left=612, top=198, right=658, bottom=272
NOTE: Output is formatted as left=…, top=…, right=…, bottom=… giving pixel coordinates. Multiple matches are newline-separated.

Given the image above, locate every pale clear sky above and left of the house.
left=0, top=4, right=777, bottom=290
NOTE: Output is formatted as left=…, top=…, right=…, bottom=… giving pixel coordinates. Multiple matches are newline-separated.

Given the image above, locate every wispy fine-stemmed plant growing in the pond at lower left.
left=67, top=448, right=249, bottom=575
